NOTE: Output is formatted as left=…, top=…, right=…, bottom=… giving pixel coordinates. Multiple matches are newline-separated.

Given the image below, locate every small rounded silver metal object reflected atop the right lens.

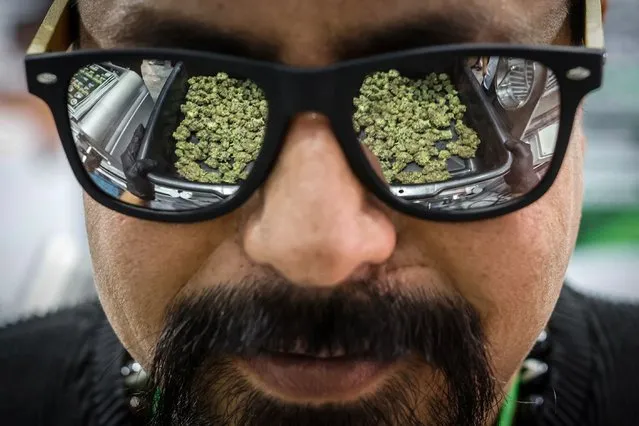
left=495, top=58, right=536, bottom=111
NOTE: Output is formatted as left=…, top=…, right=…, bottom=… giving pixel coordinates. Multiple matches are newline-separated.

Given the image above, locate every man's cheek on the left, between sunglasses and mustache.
left=85, top=196, right=233, bottom=364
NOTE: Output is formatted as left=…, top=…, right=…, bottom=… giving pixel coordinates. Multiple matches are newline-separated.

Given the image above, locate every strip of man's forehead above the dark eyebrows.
left=78, top=0, right=568, bottom=63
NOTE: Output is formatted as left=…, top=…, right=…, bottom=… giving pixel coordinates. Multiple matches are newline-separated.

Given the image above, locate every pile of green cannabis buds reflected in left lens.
left=173, top=73, right=268, bottom=184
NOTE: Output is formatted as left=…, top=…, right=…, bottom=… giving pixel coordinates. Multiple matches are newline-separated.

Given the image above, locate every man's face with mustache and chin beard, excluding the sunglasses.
left=80, top=0, right=584, bottom=424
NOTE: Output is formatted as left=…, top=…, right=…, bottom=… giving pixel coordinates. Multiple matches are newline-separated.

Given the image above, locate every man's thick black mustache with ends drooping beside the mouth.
left=151, top=281, right=494, bottom=426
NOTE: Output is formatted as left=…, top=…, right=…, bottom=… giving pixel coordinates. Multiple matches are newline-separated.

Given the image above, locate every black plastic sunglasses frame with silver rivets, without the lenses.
left=25, top=44, right=605, bottom=223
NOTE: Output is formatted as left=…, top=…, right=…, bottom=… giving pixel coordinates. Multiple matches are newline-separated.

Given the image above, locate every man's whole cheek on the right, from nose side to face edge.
left=410, top=128, right=584, bottom=381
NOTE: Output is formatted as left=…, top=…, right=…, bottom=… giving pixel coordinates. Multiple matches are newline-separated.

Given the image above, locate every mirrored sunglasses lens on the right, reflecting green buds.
left=353, top=57, right=560, bottom=211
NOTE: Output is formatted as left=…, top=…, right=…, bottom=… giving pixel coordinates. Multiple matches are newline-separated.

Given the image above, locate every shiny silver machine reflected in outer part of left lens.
left=69, top=65, right=154, bottom=174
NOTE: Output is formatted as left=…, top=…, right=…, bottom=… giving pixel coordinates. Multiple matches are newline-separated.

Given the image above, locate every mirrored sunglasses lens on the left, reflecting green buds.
left=68, top=60, right=268, bottom=211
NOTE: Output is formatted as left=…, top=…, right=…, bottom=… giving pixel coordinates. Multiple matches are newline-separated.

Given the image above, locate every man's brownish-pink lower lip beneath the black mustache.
left=242, top=354, right=392, bottom=402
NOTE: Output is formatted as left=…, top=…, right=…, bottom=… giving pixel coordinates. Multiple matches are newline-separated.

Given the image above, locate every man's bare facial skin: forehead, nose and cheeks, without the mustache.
left=80, top=0, right=604, bottom=422
